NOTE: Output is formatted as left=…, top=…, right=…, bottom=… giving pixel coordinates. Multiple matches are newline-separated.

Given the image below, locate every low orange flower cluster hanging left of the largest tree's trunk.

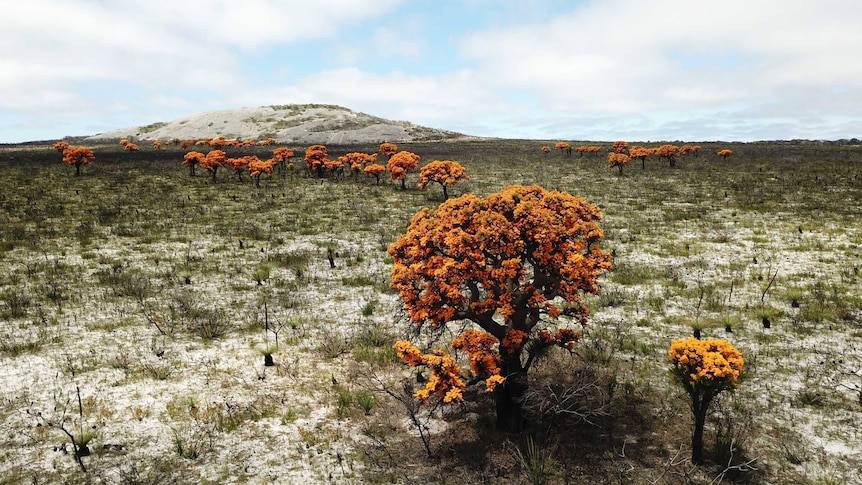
left=395, top=340, right=465, bottom=403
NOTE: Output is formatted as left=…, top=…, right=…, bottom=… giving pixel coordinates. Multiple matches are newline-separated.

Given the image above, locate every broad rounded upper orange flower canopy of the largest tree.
left=389, top=185, right=611, bottom=332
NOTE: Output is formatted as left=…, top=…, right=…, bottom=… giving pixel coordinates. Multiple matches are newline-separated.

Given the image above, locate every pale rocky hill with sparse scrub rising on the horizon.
left=85, top=104, right=465, bottom=145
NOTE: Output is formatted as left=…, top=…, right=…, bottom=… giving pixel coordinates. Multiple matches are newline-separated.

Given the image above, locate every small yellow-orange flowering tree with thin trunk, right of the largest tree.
left=668, top=337, right=744, bottom=464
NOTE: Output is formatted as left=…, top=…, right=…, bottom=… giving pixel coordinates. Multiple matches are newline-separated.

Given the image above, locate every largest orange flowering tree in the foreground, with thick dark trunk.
left=389, top=186, right=611, bottom=430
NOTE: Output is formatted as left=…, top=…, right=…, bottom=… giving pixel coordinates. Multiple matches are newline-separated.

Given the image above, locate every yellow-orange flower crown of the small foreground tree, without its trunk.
left=668, top=337, right=744, bottom=393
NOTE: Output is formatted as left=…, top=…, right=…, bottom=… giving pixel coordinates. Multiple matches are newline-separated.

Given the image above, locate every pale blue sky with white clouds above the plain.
left=0, top=0, right=862, bottom=143
